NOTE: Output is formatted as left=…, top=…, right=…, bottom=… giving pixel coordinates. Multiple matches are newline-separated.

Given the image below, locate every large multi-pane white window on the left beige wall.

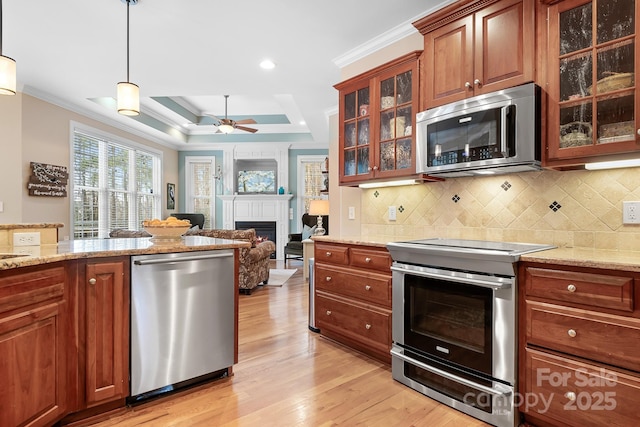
left=71, top=125, right=162, bottom=239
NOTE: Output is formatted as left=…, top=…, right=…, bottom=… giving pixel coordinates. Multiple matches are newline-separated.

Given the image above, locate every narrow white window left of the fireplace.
left=185, top=156, right=222, bottom=228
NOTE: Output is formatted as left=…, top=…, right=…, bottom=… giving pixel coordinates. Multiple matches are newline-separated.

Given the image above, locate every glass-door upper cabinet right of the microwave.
left=546, top=0, right=639, bottom=167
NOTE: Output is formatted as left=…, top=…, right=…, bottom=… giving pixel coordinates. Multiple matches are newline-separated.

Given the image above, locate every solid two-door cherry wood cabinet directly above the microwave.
left=414, top=0, right=536, bottom=109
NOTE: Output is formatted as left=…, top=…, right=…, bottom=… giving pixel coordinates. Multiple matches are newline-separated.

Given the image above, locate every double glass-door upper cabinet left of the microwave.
left=335, top=51, right=421, bottom=185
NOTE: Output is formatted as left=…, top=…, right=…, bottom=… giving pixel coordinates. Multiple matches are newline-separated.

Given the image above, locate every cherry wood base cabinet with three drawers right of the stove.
left=519, top=263, right=640, bottom=426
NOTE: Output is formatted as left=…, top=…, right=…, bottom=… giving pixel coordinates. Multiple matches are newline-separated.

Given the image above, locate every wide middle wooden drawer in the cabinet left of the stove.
left=315, top=266, right=391, bottom=308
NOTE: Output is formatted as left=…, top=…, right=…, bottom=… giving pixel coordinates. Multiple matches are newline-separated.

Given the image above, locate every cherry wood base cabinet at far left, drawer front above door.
left=0, top=263, right=69, bottom=426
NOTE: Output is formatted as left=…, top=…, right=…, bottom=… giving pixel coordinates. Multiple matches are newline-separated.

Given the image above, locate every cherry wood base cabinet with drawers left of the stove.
left=314, top=241, right=391, bottom=363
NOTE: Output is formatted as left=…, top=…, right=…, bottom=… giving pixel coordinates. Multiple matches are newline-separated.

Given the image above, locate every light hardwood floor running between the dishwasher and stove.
left=94, top=261, right=487, bottom=427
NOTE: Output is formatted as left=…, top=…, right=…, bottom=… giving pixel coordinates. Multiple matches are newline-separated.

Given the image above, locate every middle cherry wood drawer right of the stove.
left=526, top=301, right=640, bottom=371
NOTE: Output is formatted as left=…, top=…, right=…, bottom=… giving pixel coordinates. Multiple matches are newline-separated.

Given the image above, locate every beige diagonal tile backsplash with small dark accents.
left=361, top=168, right=640, bottom=250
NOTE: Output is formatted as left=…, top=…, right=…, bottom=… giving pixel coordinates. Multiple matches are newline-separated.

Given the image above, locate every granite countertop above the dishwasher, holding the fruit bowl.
left=0, top=236, right=251, bottom=270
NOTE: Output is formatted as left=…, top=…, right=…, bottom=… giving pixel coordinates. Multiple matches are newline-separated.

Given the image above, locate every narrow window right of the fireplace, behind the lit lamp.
left=295, top=155, right=329, bottom=232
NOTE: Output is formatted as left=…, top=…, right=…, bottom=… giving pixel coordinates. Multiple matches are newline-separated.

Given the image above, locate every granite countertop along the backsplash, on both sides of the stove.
left=312, top=235, right=640, bottom=272
